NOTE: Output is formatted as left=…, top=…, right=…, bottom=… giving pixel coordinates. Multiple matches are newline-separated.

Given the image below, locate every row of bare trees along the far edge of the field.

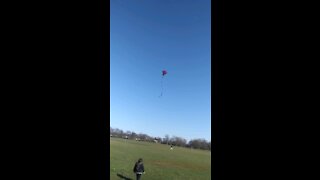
left=110, top=127, right=211, bottom=151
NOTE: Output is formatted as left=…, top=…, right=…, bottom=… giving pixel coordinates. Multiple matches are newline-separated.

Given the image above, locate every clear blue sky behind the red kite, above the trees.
left=110, top=0, right=211, bottom=141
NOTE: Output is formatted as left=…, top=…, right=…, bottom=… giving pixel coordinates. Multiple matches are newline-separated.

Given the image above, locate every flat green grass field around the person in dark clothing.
left=110, top=138, right=211, bottom=180
